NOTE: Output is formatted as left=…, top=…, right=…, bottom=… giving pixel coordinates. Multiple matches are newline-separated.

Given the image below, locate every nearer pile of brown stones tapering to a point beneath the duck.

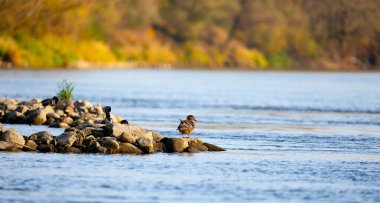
left=0, top=123, right=224, bottom=154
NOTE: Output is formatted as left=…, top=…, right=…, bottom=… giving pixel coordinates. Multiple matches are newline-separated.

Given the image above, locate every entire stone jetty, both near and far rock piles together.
left=0, top=98, right=224, bottom=154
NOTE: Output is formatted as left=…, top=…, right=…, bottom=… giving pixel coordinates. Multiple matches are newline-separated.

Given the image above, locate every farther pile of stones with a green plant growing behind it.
left=0, top=98, right=119, bottom=128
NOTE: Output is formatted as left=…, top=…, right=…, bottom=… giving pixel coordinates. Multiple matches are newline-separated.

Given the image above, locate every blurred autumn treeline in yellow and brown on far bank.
left=0, top=0, right=380, bottom=70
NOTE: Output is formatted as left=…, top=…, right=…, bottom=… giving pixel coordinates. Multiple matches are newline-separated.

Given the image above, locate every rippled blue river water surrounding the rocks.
left=0, top=70, right=380, bottom=202
